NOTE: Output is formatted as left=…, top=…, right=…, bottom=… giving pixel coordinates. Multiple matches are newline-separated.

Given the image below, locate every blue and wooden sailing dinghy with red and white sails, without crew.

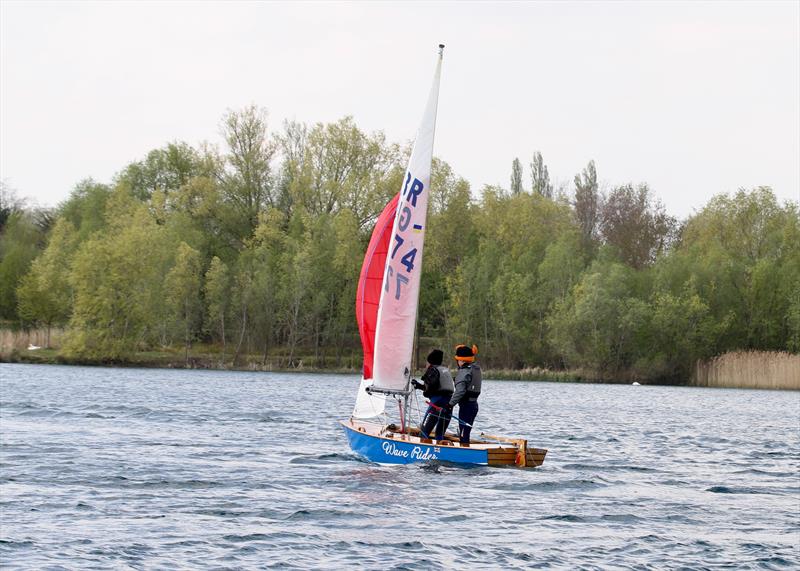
left=341, top=45, right=547, bottom=467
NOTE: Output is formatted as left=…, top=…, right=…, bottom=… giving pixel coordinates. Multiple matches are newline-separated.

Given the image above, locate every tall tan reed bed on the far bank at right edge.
left=692, top=351, right=800, bottom=390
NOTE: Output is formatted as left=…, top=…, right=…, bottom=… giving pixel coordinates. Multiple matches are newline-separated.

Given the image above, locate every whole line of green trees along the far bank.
left=0, top=106, right=800, bottom=379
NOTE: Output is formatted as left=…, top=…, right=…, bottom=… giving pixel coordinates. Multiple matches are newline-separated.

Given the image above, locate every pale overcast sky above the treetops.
left=0, top=0, right=800, bottom=217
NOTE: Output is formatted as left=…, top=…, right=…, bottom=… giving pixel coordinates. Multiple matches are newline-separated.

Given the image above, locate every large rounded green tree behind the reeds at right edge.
left=662, top=187, right=800, bottom=351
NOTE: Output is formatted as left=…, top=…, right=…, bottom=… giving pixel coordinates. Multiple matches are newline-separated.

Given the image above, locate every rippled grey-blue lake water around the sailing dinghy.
left=0, top=364, right=800, bottom=569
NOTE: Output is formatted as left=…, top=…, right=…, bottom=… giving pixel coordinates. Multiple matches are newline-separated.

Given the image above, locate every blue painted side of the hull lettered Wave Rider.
left=342, top=422, right=489, bottom=465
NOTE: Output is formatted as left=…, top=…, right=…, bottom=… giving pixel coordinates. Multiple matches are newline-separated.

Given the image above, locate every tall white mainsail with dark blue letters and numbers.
left=353, top=46, right=444, bottom=418
